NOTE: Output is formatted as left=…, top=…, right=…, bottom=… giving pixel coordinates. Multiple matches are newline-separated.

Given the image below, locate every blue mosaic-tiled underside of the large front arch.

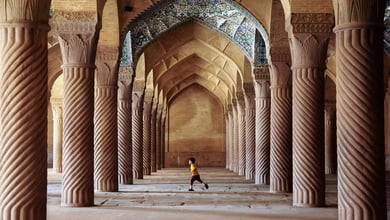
left=121, top=0, right=268, bottom=65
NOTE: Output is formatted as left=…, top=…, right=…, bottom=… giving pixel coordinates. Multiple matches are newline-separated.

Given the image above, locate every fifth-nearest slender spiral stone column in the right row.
left=244, top=83, right=256, bottom=180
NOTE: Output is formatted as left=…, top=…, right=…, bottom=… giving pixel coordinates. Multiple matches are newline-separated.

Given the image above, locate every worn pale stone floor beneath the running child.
left=47, top=168, right=337, bottom=220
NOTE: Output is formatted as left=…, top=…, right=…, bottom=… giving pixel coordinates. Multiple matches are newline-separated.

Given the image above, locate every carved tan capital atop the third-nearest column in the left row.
left=95, top=47, right=119, bottom=87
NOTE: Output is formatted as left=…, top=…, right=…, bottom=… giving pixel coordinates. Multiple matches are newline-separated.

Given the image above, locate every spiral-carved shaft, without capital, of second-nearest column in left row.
left=62, top=67, right=95, bottom=206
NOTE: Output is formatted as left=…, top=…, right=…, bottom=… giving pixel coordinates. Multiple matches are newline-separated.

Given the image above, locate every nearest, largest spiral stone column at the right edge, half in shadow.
left=334, top=0, right=387, bottom=220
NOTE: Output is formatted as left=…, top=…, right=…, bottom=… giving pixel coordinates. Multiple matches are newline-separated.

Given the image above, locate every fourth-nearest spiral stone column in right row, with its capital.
left=253, top=66, right=271, bottom=184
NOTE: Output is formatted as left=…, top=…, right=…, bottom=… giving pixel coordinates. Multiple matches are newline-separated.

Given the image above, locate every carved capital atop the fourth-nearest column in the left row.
left=118, top=67, right=134, bottom=100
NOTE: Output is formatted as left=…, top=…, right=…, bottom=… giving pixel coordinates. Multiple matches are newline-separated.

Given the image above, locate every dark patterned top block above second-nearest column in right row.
left=291, top=13, right=334, bottom=33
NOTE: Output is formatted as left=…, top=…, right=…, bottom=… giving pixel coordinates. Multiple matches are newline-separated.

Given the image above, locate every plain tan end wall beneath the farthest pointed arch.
left=165, top=84, right=226, bottom=167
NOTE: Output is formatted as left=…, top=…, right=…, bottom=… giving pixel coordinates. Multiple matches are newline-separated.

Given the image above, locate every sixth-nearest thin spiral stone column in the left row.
left=143, top=91, right=153, bottom=175
